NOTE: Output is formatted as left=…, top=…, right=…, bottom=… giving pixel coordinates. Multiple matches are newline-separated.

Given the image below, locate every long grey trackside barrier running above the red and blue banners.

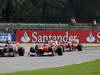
left=0, top=23, right=100, bottom=33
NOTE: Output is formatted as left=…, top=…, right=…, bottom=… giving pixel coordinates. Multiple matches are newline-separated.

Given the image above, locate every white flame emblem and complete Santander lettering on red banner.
left=20, top=31, right=76, bottom=43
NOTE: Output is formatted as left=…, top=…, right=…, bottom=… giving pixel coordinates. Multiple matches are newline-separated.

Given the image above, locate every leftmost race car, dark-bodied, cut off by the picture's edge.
left=0, top=45, right=25, bottom=57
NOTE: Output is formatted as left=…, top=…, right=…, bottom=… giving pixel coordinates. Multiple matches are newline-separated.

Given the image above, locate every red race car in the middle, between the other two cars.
left=30, top=45, right=63, bottom=56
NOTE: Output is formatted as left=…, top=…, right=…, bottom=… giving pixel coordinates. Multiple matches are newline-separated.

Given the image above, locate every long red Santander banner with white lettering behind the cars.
left=16, top=30, right=100, bottom=43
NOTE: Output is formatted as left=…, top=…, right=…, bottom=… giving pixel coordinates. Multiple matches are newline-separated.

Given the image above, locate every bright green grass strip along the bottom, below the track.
left=0, top=60, right=100, bottom=75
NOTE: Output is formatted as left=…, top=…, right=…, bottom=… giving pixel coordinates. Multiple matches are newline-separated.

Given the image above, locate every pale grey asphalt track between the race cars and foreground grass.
left=0, top=48, right=100, bottom=73
